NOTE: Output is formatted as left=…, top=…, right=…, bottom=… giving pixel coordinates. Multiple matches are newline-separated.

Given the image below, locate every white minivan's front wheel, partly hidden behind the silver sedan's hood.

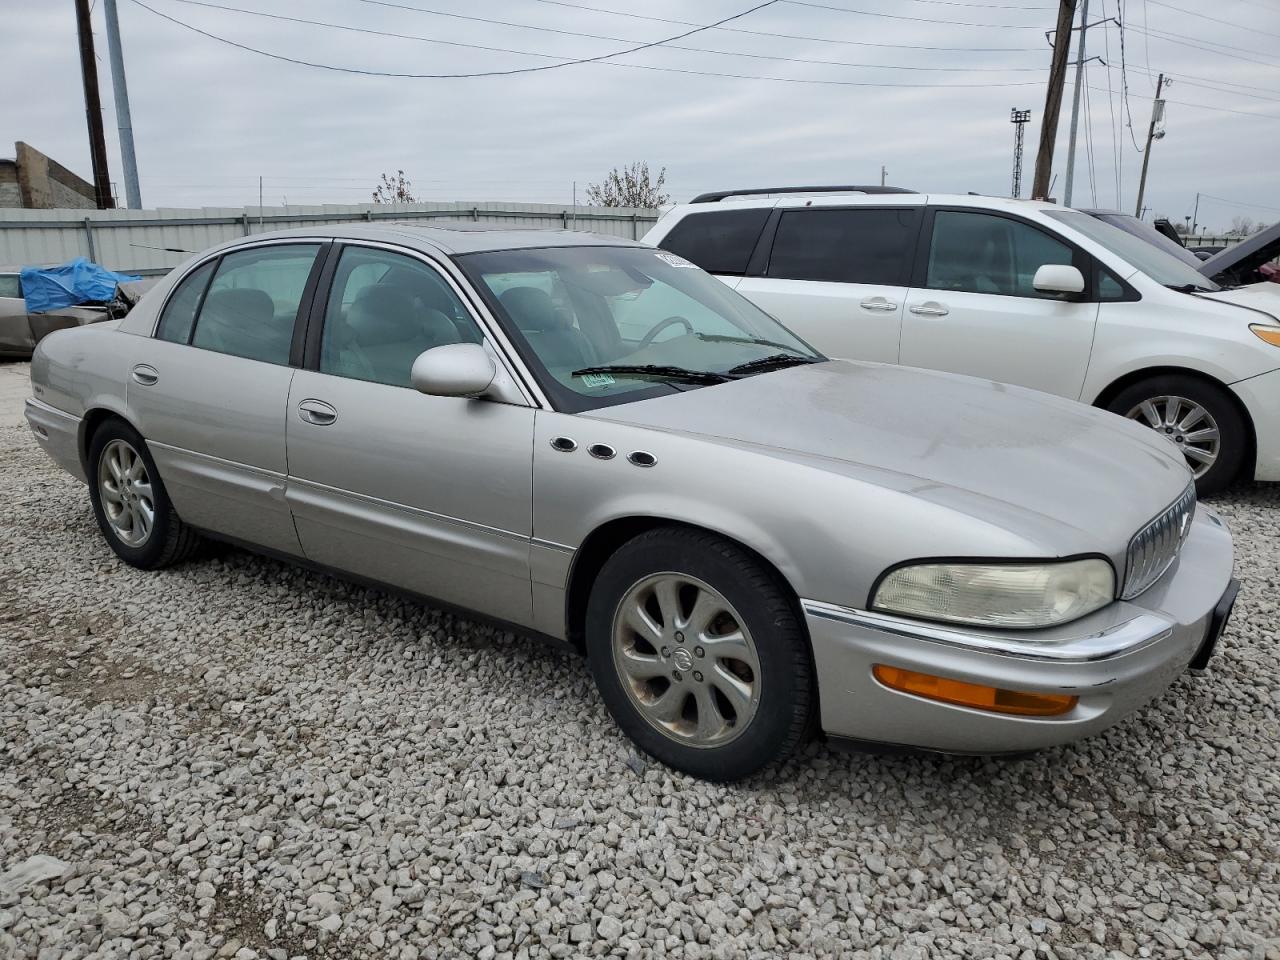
left=1107, top=374, right=1249, bottom=497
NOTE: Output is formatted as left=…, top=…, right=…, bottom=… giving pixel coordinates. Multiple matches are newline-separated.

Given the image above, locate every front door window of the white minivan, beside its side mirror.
left=924, top=210, right=1073, bottom=300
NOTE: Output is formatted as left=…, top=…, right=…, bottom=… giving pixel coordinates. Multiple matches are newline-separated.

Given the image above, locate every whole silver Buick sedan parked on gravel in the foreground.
left=27, top=224, right=1236, bottom=780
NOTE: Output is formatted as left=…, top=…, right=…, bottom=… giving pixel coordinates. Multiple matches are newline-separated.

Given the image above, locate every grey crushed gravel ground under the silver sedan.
left=0, top=414, right=1280, bottom=960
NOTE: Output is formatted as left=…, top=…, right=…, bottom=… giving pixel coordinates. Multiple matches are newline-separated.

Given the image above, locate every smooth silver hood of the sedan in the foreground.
left=590, top=360, right=1190, bottom=556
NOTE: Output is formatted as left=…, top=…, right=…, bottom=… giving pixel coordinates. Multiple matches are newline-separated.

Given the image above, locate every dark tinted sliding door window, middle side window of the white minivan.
left=765, top=209, right=918, bottom=287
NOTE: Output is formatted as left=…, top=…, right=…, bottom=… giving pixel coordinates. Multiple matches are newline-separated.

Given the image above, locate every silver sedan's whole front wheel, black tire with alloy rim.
left=586, top=527, right=817, bottom=781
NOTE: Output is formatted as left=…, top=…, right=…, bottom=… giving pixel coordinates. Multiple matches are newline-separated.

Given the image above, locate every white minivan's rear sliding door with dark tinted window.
left=737, top=204, right=920, bottom=364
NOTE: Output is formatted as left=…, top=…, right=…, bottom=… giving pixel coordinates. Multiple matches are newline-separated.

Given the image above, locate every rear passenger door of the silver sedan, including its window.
left=125, top=243, right=320, bottom=554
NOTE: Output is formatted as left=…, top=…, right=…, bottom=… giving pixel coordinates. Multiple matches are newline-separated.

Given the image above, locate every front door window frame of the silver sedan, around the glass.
left=298, top=238, right=550, bottom=408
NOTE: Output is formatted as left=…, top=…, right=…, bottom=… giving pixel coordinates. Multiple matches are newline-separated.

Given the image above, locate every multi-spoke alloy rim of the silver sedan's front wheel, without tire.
left=613, top=573, right=760, bottom=748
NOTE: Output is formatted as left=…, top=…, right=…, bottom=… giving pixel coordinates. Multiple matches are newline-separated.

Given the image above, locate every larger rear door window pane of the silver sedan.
left=191, top=243, right=320, bottom=364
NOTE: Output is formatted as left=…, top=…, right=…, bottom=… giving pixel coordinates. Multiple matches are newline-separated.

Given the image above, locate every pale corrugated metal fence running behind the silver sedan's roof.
left=0, top=202, right=658, bottom=275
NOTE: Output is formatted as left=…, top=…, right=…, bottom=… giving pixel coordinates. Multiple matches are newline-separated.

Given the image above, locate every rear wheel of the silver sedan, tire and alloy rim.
left=87, top=419, right=202, bottom=570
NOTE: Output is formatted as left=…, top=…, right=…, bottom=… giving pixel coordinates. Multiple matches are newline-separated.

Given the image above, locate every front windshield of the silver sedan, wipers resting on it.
left=457, top=246, right=824, bottom=412
